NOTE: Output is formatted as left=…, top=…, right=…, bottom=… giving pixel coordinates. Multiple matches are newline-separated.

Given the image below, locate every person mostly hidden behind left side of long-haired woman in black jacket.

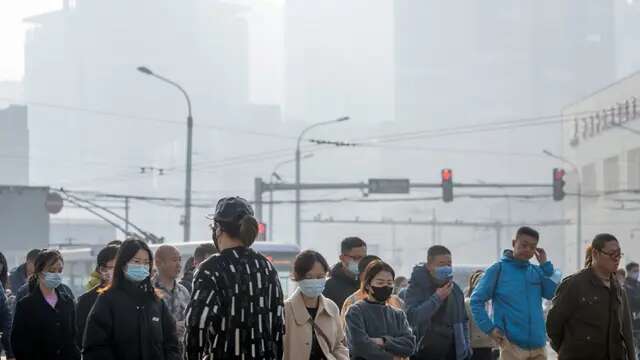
left=76, top=245, right=119, bottom=348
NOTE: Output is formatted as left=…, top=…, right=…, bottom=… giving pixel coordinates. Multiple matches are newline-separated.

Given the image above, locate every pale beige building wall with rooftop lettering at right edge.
left=558, top=72, right=640, bottom=269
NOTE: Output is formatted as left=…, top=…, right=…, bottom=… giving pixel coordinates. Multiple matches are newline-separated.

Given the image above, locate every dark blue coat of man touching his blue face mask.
left=406, top=264, right=471, bottom=360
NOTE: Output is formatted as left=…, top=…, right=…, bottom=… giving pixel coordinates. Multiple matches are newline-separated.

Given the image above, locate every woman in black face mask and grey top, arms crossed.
left=346, top=260, right=416, bottom=360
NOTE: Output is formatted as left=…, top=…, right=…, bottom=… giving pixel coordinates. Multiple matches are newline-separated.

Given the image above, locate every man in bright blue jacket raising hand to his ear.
left=471, top=227, right=557, bottom=360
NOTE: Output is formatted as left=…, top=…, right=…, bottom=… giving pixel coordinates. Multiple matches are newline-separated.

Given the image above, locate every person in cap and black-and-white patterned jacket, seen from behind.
left=184, top=197, right=284, bottom=360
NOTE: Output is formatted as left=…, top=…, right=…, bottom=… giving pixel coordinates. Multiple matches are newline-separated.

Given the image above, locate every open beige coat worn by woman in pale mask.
left=283, top=289, right=349, bottom=360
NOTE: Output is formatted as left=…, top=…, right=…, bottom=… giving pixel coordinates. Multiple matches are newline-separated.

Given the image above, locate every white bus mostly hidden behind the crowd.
left=60, top=241, right=300, bottom=297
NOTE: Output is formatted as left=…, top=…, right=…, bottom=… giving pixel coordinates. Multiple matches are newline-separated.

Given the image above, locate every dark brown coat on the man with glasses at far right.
left=547, top=269, right=636, bottom=360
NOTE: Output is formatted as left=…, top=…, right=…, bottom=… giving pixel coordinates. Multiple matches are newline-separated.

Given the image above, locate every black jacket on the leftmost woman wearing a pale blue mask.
left=11, top=287, right=80, bottom=360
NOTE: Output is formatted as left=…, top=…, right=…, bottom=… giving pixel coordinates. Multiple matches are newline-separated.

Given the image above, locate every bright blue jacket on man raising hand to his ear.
left=471, top=250, right=557, bottom=350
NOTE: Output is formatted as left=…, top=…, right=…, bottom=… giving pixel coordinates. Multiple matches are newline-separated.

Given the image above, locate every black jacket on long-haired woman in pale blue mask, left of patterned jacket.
left=82, top=279, right=180, bottom=360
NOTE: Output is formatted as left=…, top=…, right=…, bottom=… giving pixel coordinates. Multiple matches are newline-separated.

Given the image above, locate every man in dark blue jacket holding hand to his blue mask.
left=406, top=245, right=471, bottom=360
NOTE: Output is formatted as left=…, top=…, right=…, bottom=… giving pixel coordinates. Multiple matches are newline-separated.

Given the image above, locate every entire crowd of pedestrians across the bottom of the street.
left=0, top=197, right=640, bottom=360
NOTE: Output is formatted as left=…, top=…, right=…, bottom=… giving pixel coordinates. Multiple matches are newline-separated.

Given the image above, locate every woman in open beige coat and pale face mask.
left=283, top=250, right=349, bottom=360
